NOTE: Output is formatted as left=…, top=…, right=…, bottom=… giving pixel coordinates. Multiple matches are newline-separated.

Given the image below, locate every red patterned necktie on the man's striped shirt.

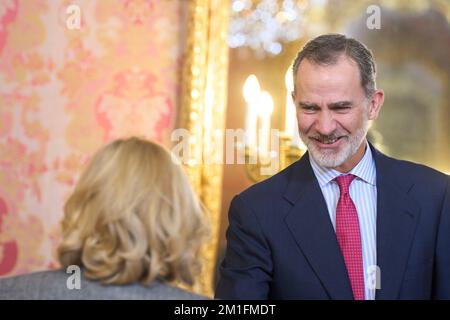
left=335, top=174, right=364, bottom=300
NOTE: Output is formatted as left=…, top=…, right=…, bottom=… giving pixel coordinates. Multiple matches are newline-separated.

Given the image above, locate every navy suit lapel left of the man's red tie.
left=284, top=154, right=353, bottom=299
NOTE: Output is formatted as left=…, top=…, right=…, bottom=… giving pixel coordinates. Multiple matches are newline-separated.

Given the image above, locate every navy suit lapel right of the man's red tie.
left=371, top=146, right=420, bottom=299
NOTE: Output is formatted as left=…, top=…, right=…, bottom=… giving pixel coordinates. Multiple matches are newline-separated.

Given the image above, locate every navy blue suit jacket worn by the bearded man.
left=216, top=146, right=450, bottom=299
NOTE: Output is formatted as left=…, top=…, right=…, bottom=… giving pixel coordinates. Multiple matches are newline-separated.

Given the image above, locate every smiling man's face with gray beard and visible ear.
left=292, top=53, right=384, bottom=172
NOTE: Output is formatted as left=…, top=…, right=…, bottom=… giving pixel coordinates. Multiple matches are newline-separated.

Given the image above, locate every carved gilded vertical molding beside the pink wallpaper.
left=178, top=0, right=230, bottom=296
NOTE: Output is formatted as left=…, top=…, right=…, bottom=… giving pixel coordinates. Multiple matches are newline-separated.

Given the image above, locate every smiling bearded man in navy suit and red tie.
left=216, top=34, right=450, bottom=300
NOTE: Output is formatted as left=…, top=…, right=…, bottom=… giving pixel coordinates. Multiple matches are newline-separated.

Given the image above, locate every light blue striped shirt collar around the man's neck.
left=309, top=140, right=376, bottom=187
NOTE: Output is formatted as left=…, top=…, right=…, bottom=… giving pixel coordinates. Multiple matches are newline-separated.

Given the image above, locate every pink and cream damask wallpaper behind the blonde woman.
left=0, top=0, right=187, bottom=276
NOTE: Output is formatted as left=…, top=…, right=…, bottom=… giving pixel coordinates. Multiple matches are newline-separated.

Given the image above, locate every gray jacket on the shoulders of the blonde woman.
left=0, top=270, right=206, bottom=300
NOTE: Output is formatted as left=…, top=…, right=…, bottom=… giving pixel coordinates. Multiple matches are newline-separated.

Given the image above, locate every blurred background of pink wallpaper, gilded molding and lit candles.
left=0, top=0, right=450, bottom=295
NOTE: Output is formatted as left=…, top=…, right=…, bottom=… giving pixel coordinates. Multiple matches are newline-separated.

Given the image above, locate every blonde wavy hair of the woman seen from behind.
left=58, top=138, right=208, bottom=284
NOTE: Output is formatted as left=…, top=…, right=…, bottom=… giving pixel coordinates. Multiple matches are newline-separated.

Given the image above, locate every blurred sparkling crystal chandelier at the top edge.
left=228, top=0, right=308, bottom=55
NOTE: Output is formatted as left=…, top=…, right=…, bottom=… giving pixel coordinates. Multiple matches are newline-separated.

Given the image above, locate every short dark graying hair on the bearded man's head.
left=292, top=34, right=376, bottom=97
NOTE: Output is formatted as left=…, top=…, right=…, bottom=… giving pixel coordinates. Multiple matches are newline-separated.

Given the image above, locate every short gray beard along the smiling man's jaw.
left=300, top=120, right=369, bottom=168
